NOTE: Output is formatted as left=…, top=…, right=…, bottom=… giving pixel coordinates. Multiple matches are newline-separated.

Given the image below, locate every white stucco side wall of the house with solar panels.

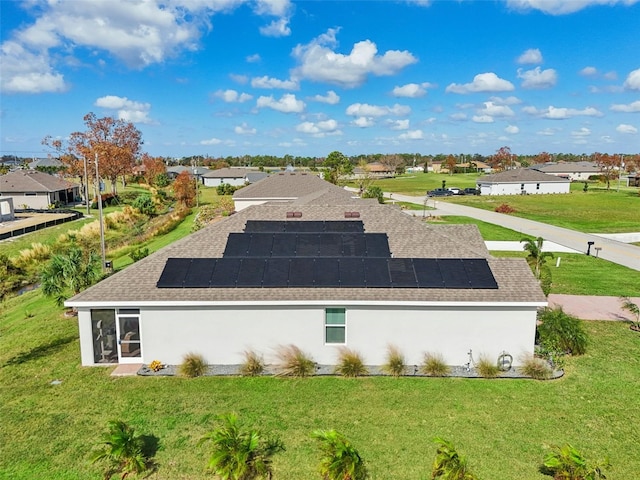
left=79, top=305, right=536, bottom=365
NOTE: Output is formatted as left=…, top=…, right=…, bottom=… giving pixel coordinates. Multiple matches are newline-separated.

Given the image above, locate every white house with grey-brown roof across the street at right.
left=476, top=168, right=571, bottom=195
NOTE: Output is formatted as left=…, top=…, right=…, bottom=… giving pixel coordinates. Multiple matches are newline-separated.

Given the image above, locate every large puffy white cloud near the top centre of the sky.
left=292, top=29, right=417, bottom=88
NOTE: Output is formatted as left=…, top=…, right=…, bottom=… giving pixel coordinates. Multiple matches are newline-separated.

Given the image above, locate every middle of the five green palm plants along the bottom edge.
left=311, top=430, right=369, bottom=480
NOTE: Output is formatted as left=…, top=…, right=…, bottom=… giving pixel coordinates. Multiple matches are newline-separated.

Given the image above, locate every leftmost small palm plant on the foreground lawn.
left=92, top=420, right=149, bottom=480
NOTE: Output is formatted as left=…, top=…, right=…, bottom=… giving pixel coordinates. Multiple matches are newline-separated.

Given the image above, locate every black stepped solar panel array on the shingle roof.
left=157, top=220, right=498, bottom=289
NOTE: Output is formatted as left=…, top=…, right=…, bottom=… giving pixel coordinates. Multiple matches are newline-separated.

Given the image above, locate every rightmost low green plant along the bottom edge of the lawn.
left=540, top=444, right=611, bottom=480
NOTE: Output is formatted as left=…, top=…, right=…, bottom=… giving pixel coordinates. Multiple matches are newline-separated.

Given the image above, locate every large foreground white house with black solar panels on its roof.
left=66, top=174, right=547, bottom=365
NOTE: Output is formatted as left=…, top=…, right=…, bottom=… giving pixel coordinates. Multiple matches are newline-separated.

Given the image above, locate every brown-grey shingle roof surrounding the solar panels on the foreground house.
left=69, top=201, right=545, bottom=305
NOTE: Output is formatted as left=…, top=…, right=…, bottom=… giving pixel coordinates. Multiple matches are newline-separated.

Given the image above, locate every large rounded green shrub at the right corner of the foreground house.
left=537, top=307, right=589, bottom=355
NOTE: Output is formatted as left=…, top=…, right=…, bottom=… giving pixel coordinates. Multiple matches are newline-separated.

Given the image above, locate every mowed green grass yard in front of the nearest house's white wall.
left=0, top=291, right=640, bottom=480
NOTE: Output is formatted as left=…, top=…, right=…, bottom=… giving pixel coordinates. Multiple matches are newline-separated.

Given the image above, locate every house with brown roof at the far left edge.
left=0, top=170, right=80, bottom=209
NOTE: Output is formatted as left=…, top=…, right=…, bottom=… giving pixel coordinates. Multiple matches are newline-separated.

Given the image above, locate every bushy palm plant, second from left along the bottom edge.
left=199, top=413, right=285, bottom=480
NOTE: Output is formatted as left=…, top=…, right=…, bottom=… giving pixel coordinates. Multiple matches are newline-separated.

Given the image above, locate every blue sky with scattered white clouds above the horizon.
left=0, top=0, right=640, bottom=157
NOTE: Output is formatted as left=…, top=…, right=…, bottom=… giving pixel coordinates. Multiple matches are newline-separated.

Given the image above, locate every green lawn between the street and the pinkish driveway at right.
left=491, top=252, right=640, bottom=297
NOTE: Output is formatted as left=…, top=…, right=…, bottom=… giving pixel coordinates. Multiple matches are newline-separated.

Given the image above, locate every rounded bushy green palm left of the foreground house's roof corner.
left=40, top=247, right=100, bottom=305
